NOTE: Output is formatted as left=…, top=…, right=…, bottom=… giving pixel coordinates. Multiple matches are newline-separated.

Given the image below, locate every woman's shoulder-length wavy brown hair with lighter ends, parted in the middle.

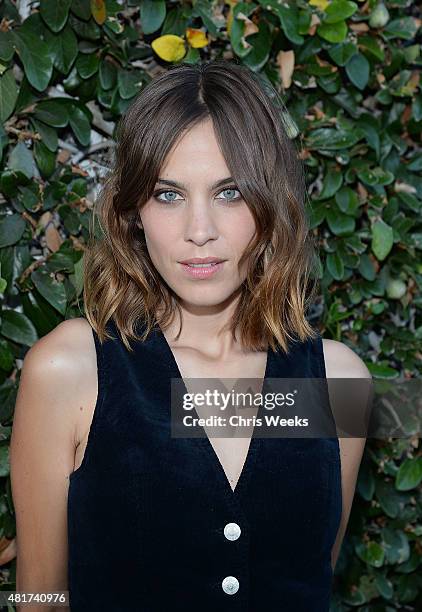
left=83, top=60, right=317, bottom=351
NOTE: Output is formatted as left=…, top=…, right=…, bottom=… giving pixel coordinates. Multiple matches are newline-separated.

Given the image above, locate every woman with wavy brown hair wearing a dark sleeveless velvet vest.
left=12, top=61, right=369, bottom=612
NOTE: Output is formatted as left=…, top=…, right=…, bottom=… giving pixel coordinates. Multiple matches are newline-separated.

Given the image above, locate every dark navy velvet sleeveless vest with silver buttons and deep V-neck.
left=68, top=321, right=342, bottom=612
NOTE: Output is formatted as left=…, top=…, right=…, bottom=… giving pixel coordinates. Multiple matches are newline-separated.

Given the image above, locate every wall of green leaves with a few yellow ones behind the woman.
left=0, top=0, right=422, bottom=612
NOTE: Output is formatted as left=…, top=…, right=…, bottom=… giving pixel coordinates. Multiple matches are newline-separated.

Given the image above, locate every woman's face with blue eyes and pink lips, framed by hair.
left=140, top=120, right=255, bottom=307
